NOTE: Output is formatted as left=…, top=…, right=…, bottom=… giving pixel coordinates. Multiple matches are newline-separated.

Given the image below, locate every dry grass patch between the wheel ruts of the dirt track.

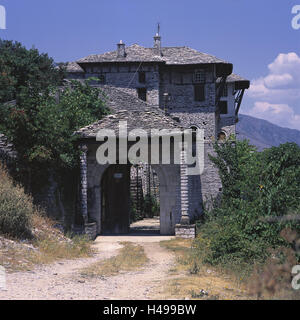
left=81, top=242, right=148, bottom=277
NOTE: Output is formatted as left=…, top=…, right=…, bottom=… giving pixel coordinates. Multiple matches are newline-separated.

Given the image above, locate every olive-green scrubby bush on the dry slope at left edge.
left=0, top=165, right=34, bottom=238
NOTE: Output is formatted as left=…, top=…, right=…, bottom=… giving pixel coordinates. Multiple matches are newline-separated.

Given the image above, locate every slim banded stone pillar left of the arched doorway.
left=79, top=144, right=88, bottom=225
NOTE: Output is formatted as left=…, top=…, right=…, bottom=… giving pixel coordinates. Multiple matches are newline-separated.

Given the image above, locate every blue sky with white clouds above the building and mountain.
left=0, top=0, right=300, bottom=129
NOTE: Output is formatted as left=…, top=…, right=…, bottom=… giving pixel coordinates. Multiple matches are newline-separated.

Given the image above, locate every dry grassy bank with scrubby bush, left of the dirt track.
left=0, top=166, right=92, bottom=271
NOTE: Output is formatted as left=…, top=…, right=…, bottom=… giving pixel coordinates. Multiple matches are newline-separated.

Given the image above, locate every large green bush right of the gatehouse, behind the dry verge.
left=194, top=140, right=300, bottom=265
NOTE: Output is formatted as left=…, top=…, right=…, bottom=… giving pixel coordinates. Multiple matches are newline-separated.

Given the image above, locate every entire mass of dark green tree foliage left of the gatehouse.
left=0, top=41, right=108, bottom=190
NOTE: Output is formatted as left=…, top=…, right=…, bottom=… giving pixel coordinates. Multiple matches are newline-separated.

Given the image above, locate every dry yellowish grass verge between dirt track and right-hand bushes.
left=160, top=239, right=251, bottom=300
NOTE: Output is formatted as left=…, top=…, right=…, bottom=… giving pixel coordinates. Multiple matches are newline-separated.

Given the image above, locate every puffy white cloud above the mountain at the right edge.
left=244, top=52, right=300, bottom=130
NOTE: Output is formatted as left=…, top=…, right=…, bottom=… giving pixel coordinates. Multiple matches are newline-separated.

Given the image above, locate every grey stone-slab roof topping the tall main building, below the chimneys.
left=76, top=44, right=228, bottom=65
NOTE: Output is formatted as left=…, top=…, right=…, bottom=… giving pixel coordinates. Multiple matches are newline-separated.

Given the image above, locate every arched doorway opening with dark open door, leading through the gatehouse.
left=101, top=164, right=160, bottom=235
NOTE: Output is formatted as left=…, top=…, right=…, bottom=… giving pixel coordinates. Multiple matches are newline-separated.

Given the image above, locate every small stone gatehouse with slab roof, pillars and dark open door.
left=78, top=85, right=201, bottom=235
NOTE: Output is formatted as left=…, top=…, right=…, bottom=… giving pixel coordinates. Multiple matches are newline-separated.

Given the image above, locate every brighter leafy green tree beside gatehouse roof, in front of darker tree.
left=0, top=80, right=108, bottom=189
